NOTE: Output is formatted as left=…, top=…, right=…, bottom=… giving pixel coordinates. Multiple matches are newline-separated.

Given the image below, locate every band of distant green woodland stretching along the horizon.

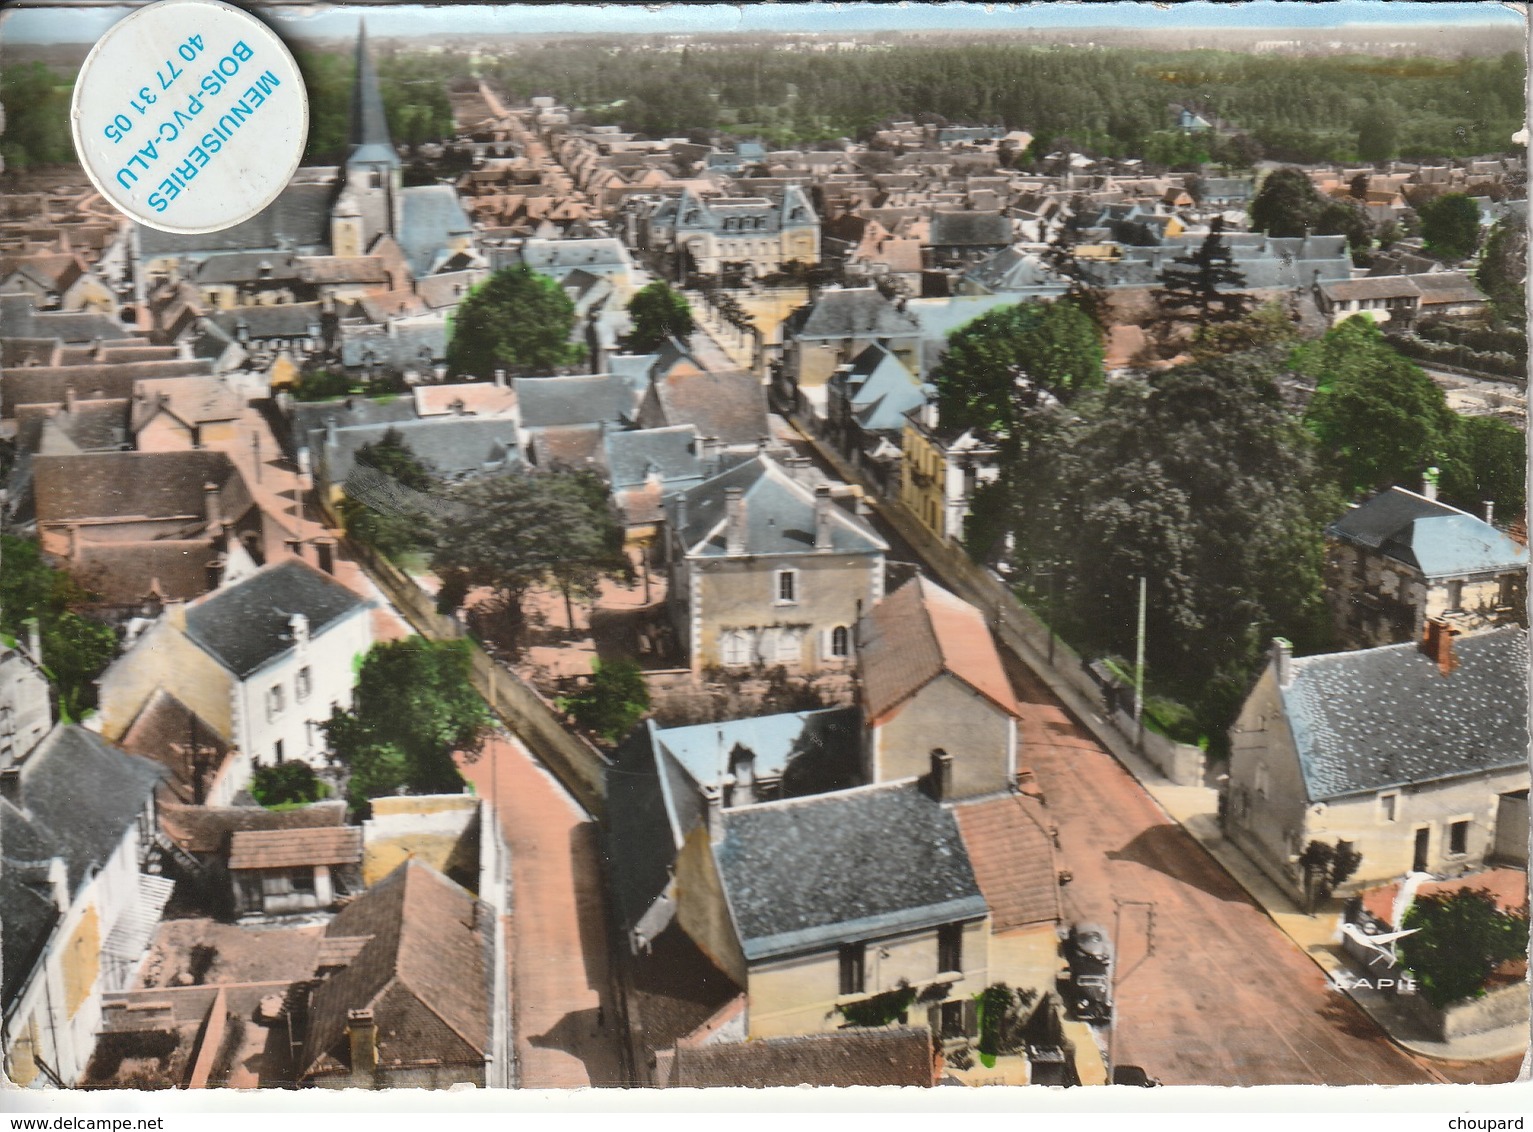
left=0, top=40, right=1525, bottom=169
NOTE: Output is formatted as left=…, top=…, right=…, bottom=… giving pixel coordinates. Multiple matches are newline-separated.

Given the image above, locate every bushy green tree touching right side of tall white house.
left=325, top=637, right=491, bottom=813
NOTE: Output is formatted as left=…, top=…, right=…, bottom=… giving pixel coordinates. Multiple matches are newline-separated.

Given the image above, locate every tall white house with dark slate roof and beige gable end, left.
left=100, top=558, right=373, bottom=782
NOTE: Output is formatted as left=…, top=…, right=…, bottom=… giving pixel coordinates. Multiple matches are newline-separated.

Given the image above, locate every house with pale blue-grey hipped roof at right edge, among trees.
left=1326, top=482, right=1528, bottom=647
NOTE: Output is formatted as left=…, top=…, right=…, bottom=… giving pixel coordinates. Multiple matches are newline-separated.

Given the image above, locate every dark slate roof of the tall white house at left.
left=185, top=558, right=368, bottom=678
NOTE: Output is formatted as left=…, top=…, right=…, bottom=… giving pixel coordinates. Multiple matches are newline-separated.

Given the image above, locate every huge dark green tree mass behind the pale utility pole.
left=1013, top=350, right=1340, bottom=736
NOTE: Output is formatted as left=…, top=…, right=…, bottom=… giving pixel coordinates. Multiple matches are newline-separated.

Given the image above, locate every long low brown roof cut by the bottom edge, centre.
left=668, top=1028, right=937, bottom=1089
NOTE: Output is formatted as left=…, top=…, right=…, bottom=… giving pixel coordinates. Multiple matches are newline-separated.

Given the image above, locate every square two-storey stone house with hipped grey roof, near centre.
left=665, top=454, right=889, bottom=678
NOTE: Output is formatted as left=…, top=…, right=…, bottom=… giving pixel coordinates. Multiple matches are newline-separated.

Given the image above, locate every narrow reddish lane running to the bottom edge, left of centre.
left=463, top=738, right=625, bottom=1089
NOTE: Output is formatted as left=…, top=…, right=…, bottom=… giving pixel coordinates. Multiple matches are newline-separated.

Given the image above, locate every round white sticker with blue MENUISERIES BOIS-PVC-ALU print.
left=71, top=0, right=308, bottom=233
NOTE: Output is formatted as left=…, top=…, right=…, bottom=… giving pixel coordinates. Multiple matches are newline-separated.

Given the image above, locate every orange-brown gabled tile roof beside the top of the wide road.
left=857, top=575, right=1018, bottom=722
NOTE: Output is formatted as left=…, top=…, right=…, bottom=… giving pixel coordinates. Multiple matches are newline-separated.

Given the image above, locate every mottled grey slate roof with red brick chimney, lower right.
left=1282, top=626, right=1528, bottom=802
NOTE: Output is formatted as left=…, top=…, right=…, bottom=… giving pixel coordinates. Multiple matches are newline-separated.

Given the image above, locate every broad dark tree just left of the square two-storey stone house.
left=432, top=472, right=627, bottom=644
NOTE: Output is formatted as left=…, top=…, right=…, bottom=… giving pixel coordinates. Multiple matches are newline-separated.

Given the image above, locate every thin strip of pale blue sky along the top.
left=0, top=0, right=1527, bottom=43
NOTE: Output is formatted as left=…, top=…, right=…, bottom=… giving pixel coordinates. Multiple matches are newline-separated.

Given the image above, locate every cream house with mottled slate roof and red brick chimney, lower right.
left=1223, top=621, right=1528, bottom=894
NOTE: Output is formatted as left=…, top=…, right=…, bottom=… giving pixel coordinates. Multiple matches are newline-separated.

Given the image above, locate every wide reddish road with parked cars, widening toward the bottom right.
left=1007, top=656, right=1439, bottom=1084
